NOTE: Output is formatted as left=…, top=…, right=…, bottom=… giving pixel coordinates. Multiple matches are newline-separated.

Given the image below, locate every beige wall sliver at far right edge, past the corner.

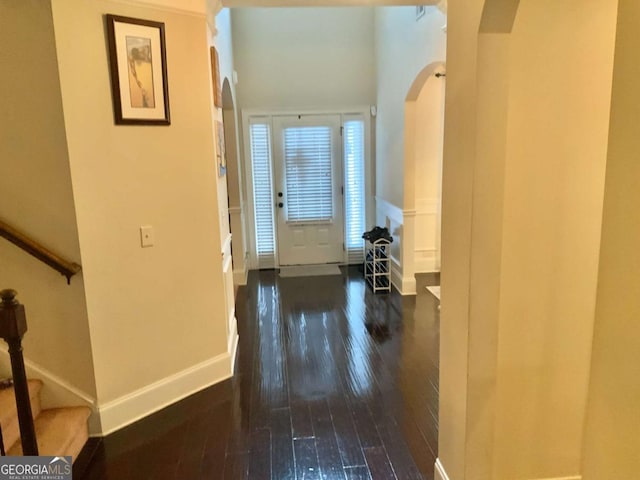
left=583, top=0, right=640, bottom=480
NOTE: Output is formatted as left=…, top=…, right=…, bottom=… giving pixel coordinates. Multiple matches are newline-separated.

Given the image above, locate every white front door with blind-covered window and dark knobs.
left=273, top=115, right=344, bottom=266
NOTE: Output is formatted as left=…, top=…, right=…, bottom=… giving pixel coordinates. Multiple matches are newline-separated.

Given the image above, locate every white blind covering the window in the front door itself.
left=284, top=126, right=333, bottom=223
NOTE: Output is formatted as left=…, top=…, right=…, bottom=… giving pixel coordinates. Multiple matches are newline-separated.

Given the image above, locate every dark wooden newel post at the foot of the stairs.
left=0, top=290, right=38, bottom=455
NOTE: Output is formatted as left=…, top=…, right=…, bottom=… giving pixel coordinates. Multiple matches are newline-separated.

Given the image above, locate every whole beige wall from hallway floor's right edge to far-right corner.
left=440, top=0, right=616, bottom=479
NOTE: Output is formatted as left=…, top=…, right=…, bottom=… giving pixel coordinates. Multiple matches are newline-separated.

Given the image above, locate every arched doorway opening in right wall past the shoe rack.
left=402, top=62, right=445, bottom=292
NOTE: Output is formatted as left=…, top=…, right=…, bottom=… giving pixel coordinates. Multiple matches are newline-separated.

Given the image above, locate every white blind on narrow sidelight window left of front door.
left=249, top=119, right=275, bottom=268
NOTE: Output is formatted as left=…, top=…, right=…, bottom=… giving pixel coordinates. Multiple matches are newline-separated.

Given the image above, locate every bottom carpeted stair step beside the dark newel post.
left=7, top=407, right=91, bottom=460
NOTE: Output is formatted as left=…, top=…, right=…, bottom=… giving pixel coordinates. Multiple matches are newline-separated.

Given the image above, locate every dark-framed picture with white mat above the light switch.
left=106, top=15, right=171, bottom=125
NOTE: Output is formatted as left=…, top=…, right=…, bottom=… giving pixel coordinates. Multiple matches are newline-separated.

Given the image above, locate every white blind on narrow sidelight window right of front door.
left=343, top=117, right=365, bottom=264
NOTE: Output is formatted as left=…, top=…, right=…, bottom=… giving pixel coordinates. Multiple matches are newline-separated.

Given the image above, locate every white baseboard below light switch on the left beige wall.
left=98, top=350, right=237, bottom=435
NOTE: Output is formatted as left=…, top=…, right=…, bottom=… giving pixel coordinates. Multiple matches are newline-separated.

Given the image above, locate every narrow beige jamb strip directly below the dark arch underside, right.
left=466, top=34, right=510, bottom=479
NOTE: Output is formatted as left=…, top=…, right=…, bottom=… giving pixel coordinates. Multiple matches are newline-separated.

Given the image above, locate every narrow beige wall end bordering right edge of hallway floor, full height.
left=438, top=0, right=490, bottom=480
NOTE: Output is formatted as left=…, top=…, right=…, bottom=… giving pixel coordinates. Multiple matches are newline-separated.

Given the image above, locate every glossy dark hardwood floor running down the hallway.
left=74, top=267, right=439, bottom=480
